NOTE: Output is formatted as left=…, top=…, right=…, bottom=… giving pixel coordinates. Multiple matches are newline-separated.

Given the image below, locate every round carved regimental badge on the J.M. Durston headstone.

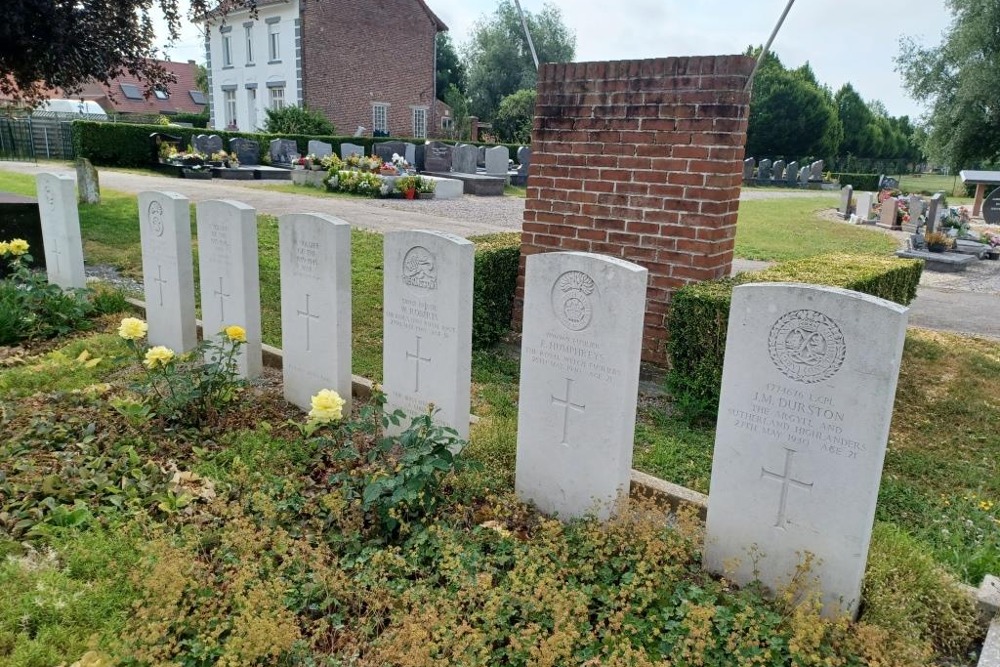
left=767, top=310, right=847, bottom=384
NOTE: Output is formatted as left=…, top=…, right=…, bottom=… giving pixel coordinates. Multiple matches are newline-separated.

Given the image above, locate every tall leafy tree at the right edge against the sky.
left=896, top=0, right=1000, bottom=171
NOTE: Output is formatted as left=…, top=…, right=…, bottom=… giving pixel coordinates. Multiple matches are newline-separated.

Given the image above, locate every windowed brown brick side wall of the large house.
left=301, top=0, right=440, bottom=137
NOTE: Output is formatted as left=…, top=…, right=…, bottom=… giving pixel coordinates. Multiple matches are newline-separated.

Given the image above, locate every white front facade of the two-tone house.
left=205, top=0, right=303, bottom=132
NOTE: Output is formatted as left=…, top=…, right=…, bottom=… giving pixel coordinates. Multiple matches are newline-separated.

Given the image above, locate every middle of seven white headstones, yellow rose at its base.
left=278, top=213, right=351, bottom=415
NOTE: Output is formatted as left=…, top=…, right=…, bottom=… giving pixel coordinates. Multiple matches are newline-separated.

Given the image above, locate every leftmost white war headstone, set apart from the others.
left=36, top=171, right=87, bottom=289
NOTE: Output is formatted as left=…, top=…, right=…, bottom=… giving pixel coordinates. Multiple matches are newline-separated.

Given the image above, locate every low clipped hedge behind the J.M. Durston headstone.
left=667, top=254, right=924, bottom=421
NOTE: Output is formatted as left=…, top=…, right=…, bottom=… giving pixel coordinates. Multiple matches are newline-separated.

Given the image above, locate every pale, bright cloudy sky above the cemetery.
left=161, top=0, right=951, bottom=120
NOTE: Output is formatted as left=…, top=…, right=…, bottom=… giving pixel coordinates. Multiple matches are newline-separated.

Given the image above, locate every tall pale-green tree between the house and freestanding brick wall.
left=464, top=0, right=576, bottom=120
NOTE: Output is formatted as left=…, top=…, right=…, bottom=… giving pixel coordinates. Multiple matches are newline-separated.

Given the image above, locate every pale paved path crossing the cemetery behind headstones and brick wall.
left=0, top=162, right=1000, bottom=340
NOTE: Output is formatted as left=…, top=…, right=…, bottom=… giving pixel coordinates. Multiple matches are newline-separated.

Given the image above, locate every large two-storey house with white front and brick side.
left=205, top=0, right=448, bottom=138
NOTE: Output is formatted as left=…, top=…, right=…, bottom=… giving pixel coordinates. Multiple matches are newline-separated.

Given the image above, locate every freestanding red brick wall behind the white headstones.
left=514, top=56, right=753, bottom=363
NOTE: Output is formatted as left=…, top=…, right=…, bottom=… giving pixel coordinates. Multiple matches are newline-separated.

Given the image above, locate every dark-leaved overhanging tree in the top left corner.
left=0, top=0, right=209, bottom=106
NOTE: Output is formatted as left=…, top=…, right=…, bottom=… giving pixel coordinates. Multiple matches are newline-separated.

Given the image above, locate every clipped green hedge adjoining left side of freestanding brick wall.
left=469, top=232, right=521, bottom=350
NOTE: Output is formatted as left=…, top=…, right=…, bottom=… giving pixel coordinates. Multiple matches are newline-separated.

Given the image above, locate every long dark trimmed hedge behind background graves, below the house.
left=73, top=120, right=518, bottom=167
